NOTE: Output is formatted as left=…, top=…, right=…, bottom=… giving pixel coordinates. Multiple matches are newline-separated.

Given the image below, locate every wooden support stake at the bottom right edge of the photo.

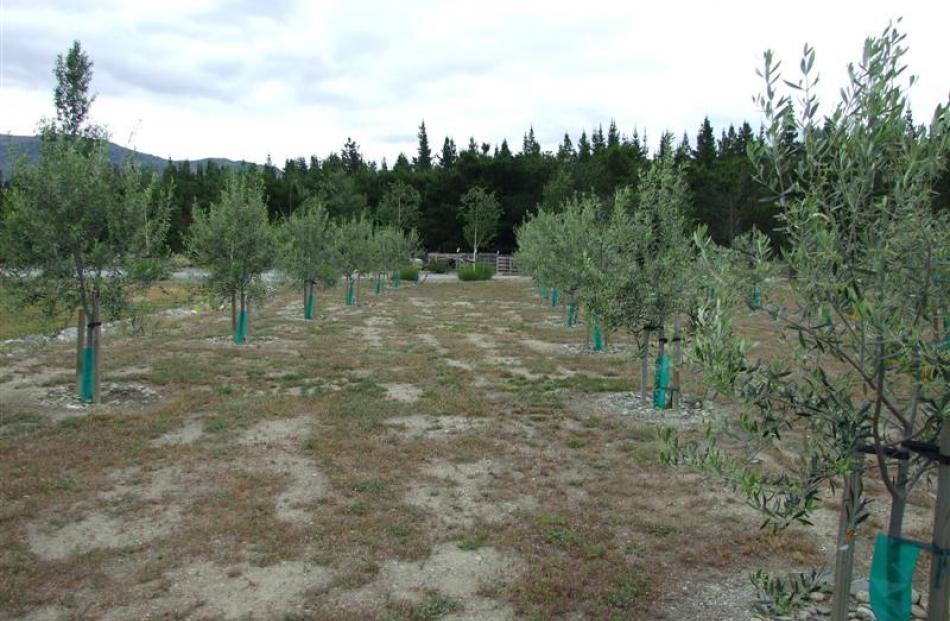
left=927, top=421, right=950, bottom=621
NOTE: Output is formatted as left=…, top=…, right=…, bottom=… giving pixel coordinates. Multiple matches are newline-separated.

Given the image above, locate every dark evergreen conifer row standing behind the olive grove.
left=156, top=119, right=792, bottom=252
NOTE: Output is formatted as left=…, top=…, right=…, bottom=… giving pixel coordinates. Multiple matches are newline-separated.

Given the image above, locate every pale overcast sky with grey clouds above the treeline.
left=0, top=0, right=950, bottom=164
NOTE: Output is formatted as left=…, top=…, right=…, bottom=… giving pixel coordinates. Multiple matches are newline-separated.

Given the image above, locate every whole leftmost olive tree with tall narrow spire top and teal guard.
left=0, top=41, right=171, bottom=402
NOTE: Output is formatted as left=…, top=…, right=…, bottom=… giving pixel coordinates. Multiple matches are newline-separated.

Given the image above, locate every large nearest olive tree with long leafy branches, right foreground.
left=666, top=26, right=950, bottom=621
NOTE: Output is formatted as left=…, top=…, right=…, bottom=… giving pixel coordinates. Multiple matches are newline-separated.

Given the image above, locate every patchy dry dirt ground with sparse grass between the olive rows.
left=0, top=279, right=932, bottom=621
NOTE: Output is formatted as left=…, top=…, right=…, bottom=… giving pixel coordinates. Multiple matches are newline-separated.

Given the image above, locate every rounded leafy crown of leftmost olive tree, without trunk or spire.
left=0, top=133, right=170, bottom=317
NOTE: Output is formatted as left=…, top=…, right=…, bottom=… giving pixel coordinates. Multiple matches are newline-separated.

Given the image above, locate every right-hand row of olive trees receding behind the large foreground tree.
left=517, top=145, right=701, bottom=408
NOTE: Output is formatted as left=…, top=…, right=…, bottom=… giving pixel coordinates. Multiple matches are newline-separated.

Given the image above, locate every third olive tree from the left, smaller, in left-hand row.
left=279, top=197, right=339, bottom=319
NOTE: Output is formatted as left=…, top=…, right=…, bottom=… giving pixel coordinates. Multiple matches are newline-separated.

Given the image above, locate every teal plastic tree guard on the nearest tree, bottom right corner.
left=868, top=533, right=920, bottom=621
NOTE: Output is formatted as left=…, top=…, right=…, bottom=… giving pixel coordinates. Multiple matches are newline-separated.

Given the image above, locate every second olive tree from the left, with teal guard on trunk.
left=188, top=171, right=277, bottom=343
